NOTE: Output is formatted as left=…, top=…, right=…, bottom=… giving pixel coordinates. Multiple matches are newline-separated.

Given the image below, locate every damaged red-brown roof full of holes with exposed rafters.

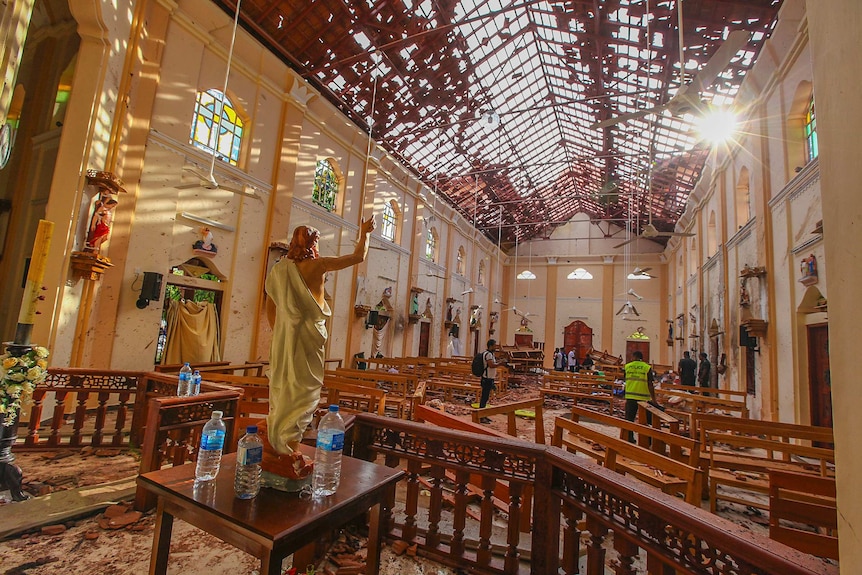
left=228, top=0, right=781, bottom=244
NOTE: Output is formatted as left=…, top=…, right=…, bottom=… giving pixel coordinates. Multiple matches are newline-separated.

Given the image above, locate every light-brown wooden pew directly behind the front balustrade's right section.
left=551, top=414, right=703, bottom=505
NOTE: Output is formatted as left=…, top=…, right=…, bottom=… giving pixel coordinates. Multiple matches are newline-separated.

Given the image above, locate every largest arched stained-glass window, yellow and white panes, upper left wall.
left=189, top=89, right=243, bottom=166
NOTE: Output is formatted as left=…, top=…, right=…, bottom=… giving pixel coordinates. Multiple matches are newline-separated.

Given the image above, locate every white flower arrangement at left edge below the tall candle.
left=0, top=347, right=49, bottom=427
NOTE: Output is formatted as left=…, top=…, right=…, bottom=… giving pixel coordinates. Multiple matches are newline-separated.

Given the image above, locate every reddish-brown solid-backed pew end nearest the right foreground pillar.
left=769, top=469, right=838, bottom=559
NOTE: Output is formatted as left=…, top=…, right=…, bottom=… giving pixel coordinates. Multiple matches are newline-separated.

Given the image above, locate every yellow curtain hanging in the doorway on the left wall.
left=162, top=300, right=221, bottom=364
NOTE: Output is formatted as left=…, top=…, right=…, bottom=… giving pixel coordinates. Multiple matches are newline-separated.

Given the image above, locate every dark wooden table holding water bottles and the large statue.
left=138, top=446, right=404, bottom=575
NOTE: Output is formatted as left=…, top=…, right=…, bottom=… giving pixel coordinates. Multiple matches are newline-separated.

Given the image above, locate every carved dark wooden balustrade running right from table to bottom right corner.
left=352, top=414, right=838, bottom=575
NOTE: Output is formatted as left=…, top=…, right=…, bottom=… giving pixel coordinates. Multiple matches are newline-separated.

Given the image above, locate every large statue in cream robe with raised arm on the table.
left=258, top=217, right=375, bottom=484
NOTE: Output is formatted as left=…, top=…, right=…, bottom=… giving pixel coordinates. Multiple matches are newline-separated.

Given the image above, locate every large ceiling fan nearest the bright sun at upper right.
left=590, top=27, right=751, bottom=129
